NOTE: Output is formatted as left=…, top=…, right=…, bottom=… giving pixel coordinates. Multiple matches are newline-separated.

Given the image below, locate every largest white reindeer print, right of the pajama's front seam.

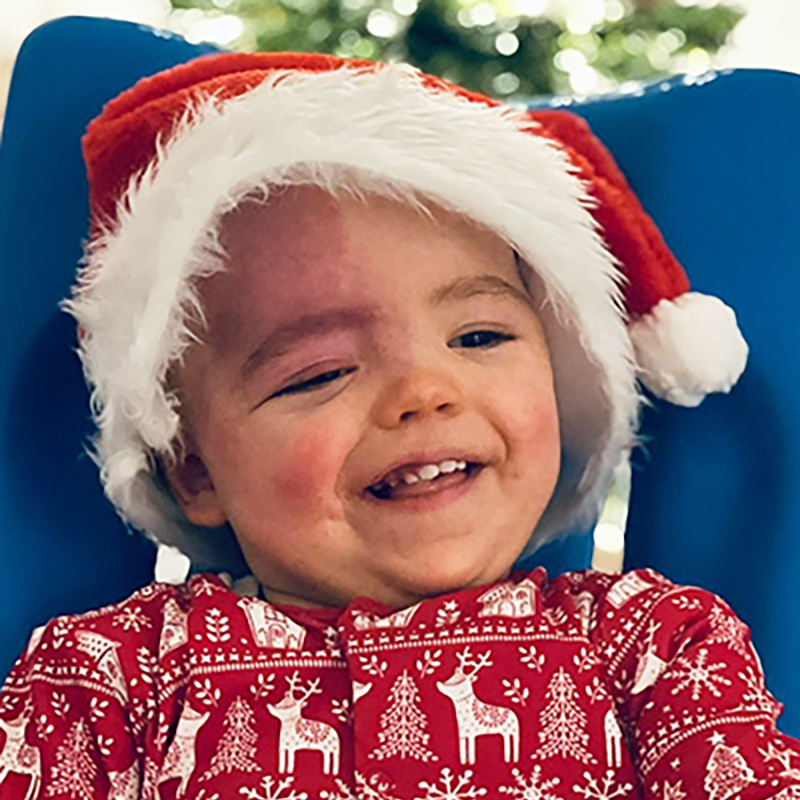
left=436, top=647, right=519, bottom=764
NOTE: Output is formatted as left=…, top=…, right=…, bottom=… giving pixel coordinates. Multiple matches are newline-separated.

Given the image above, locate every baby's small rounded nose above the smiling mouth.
left=376, top=370, right=464, bottom=428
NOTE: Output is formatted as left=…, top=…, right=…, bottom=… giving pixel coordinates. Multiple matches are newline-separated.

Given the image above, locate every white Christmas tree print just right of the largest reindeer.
left=536, top=667, right=596, bottom=764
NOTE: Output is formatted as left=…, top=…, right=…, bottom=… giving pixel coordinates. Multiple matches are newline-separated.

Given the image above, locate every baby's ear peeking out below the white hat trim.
left=159, top=436, right=228, bottom=528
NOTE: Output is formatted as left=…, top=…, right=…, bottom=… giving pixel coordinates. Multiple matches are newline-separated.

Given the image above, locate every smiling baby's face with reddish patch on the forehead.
left=167, top=188, right=560, bottom=606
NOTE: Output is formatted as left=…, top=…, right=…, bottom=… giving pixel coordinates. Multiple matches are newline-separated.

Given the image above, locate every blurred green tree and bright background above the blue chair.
left=0, top=0, right=800, bottom=122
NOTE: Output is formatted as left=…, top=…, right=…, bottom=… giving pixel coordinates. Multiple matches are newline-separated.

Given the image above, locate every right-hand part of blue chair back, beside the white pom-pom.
left=574, top=70, right=800, bottom=736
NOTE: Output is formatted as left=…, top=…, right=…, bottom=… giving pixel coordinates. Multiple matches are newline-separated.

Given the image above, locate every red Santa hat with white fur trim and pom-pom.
left=65, top=54, right=747, bottom=567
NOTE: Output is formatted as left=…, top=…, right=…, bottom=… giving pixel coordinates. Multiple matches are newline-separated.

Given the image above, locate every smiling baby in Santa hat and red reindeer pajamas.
left=0, top=48, right=800, bottom=800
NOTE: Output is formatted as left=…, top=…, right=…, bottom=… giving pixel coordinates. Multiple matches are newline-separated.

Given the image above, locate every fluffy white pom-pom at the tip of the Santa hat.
left=629, top=292, right=748, bottom=407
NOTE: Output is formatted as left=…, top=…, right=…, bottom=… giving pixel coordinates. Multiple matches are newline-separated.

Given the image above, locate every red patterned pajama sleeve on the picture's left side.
left=0, top=592, right=165, bottom=800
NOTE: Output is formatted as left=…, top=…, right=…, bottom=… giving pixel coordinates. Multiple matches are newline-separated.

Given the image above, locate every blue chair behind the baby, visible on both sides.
left=0, top=18, right=800, bottom=735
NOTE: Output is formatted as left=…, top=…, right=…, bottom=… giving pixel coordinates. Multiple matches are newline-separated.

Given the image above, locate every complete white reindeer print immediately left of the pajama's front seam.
left=267, top=672, right=339, bottom=775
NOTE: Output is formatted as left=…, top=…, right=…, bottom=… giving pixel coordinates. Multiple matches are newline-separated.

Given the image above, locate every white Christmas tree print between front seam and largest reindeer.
left=369, top=669, right=438, bottom=761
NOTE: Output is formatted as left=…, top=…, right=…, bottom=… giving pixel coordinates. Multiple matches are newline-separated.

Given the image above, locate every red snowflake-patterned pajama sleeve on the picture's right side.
left=587, top=570, right=800, bottom=800
